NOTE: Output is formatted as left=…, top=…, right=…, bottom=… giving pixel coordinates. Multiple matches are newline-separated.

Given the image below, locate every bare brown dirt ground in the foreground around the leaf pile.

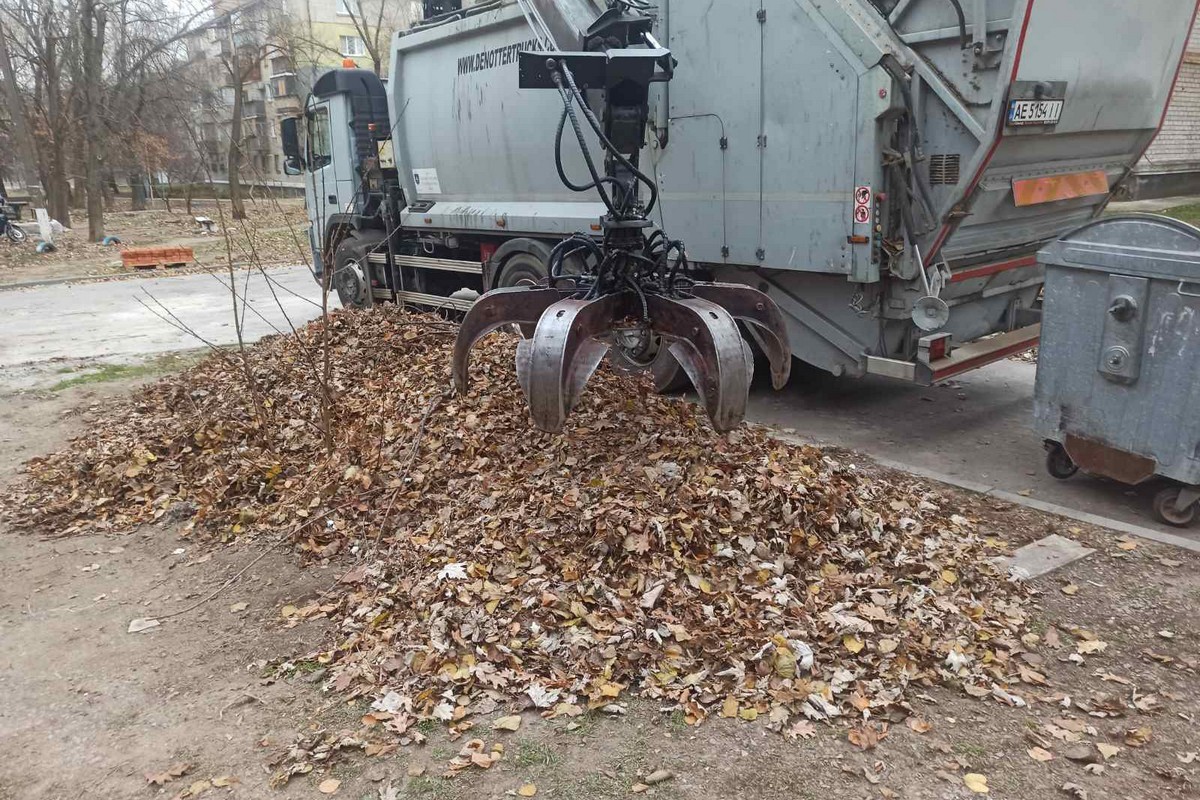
left=0, top=371, right=1200, bottom=800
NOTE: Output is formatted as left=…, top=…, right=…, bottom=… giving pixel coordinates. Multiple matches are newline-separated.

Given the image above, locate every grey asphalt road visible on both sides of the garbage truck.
left=0, top=266, right=1200, bottom=542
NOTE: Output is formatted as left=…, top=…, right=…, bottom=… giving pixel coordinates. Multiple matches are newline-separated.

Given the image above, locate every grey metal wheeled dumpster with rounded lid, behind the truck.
left=1034, top=215, right=1200, bottom=527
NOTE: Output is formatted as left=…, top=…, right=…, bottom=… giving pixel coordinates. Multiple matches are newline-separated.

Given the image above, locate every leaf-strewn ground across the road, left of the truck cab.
left=0, top=197, right=310, bottom=287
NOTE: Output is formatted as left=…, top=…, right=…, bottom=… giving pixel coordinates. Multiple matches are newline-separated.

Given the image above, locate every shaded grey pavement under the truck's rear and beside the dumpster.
left=748, top=361, right=1200, bottom=549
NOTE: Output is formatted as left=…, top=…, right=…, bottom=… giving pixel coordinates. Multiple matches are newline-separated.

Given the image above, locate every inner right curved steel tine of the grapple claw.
left=647, top=295, right=754, bottom=433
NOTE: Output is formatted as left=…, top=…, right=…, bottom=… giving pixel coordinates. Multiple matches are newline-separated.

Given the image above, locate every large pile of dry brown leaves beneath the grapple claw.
left=0, top=309, right=1028, bottom=736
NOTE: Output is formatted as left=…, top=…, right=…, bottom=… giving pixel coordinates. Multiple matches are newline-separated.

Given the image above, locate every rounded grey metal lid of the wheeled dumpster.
left=1038, top=213, right=1200, bottom=281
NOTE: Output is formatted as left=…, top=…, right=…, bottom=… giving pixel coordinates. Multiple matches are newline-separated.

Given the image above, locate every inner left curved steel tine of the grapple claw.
left=526, top=293, right=625, bottom=433
